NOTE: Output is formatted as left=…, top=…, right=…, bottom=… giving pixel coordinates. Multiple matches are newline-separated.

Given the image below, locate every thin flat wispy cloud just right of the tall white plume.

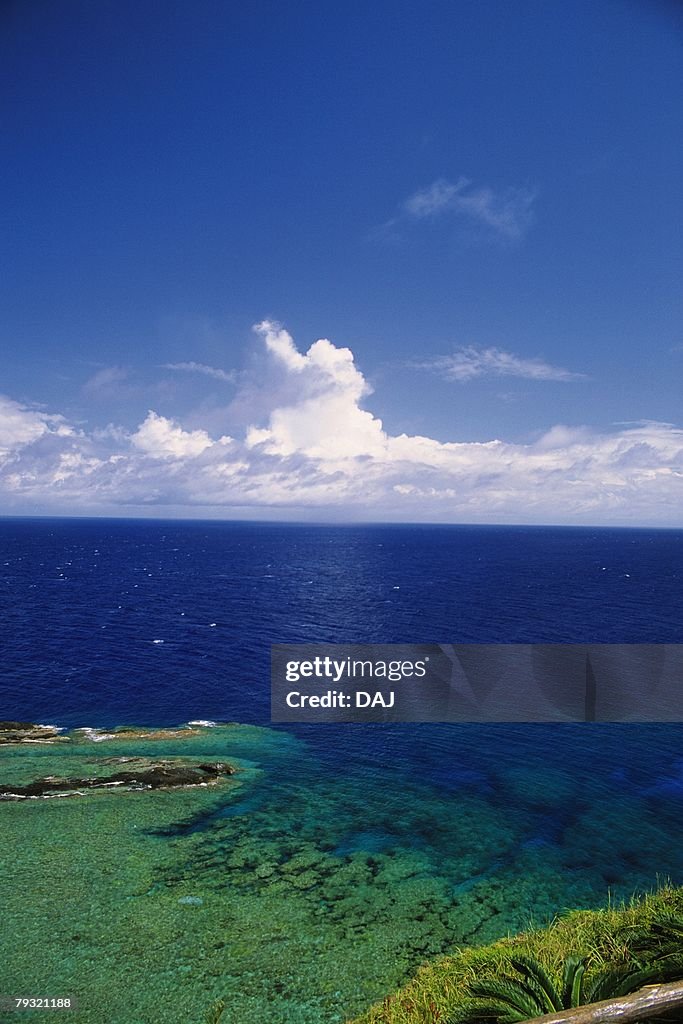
left=419, top=345, right=587, bottom=381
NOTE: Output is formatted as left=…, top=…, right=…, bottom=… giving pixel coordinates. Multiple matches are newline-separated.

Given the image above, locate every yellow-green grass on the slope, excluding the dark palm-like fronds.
left=348, top=885, right=683, bottom=1024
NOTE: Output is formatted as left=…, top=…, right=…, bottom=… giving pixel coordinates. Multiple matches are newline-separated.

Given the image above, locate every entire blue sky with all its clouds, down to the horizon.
left=0, top=0, right=683, bottom=525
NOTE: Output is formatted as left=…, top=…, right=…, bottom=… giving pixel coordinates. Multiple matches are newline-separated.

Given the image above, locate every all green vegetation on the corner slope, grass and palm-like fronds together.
left=354, top=886, right=683, bottom=1024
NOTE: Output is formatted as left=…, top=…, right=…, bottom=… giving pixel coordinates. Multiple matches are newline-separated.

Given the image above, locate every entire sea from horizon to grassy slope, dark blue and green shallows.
left=0, top=519, right=683, bottom=1024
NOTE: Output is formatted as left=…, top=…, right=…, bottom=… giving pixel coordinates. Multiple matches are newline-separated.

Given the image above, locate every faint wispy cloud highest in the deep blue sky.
left=393, top=177, right=537, bottom=241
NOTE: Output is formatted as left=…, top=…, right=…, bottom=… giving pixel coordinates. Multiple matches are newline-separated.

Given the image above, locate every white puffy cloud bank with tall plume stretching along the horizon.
left=0, top=321, right=683, bottom=525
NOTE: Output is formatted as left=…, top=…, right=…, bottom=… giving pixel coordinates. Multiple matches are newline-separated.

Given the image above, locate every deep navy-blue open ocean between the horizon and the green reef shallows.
left=0, top=519, right=683, bottom=819
